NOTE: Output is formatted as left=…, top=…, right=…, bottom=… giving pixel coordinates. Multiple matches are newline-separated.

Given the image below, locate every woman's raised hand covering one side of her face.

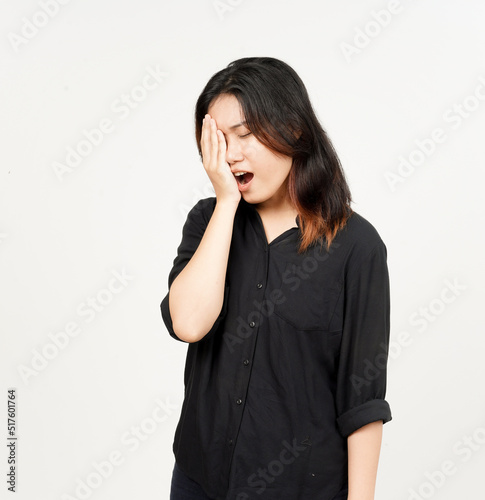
left=200, top=114, right=241, bottom=204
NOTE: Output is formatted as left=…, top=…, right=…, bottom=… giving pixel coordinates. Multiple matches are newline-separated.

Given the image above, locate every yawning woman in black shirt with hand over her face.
left=161, top=57, right=392, bottom=500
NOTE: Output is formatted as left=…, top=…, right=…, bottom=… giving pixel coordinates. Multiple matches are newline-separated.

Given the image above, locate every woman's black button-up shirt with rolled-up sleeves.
left=161, top=197, right=392, bottom=500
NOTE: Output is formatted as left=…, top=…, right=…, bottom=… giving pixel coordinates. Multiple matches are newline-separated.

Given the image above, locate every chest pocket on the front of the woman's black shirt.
left=274, top=261, right=342, bottom=331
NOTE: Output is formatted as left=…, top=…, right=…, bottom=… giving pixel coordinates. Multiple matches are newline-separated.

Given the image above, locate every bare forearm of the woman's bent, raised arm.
left=169, top=202, right=237, bottom=342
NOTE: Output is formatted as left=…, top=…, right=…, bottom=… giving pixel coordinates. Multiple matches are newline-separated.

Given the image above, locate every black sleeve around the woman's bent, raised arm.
left=160, top=199, right=229, bottom=342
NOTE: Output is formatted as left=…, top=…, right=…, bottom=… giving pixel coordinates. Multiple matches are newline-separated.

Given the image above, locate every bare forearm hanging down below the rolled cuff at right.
left=347, top=420, right=383, bottom=500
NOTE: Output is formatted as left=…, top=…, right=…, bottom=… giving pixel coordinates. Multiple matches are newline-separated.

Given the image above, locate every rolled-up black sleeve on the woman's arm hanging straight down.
left=336, top=240, right=392, bottom=437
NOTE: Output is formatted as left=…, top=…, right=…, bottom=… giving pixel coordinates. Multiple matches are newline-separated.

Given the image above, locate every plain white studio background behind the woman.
left=0, top=0, right=485, bottom=500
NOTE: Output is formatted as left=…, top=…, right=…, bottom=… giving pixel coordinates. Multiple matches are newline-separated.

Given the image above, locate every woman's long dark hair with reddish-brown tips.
left=195, top=57, right=352, bottom=253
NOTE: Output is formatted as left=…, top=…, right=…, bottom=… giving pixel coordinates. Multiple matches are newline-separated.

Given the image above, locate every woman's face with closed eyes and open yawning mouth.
left=207, top=94, right=292, bottom=208
